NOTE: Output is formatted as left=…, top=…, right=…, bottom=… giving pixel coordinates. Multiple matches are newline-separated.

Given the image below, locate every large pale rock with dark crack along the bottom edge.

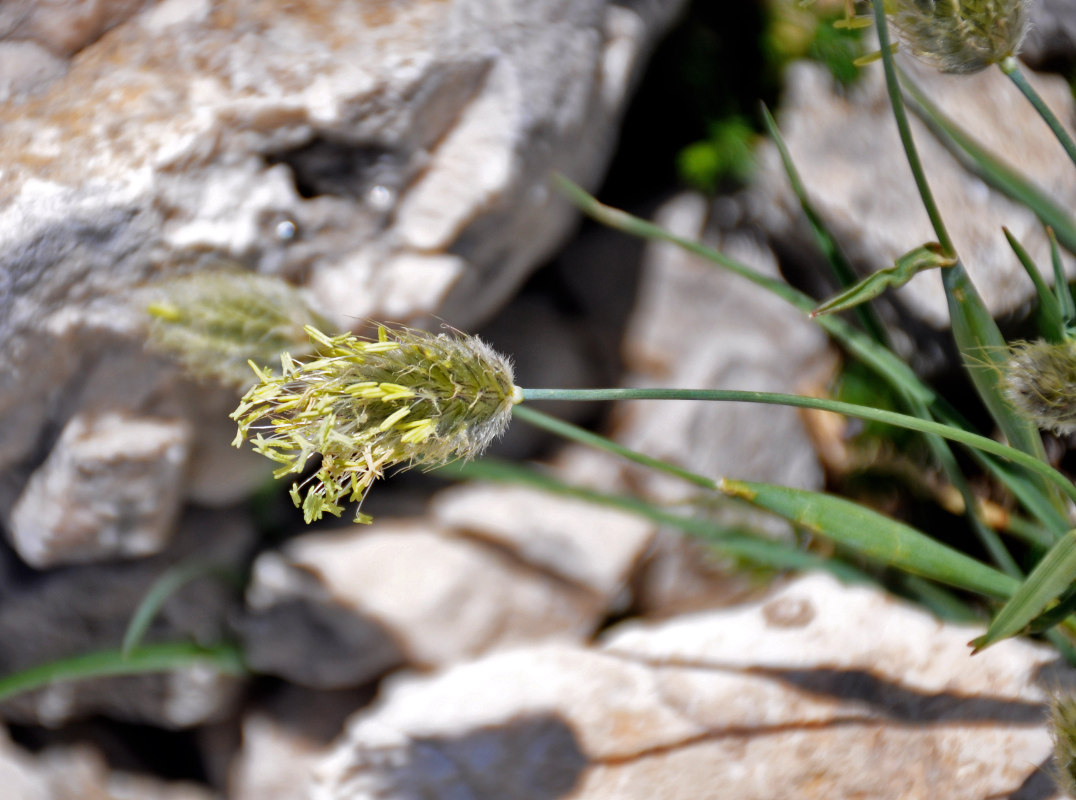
left=309, top=576, right=1072, bottom=800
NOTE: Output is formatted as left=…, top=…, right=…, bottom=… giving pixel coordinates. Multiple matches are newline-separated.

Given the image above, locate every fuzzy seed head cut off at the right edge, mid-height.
left=1001, top=339, right=1076, bottom=434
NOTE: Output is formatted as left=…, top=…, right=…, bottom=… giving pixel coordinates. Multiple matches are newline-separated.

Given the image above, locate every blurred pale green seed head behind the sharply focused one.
left=146, top=269, right=325, bottom=390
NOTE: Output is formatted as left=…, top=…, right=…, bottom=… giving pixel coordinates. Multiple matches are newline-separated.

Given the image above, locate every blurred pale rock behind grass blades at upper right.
left=756, top=60, right=1076, bottom=328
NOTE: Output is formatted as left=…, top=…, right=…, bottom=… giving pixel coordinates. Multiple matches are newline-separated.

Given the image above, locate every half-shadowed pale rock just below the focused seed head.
left=241, top=520, right=605, bottom=688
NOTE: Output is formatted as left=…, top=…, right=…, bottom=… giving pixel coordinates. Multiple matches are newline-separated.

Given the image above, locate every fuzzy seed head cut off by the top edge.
left=886, top=0, right=1031, bottom=73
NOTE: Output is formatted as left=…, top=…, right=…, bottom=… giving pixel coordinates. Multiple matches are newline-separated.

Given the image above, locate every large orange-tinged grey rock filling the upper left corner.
left=0, top=0, right=683, bottom=568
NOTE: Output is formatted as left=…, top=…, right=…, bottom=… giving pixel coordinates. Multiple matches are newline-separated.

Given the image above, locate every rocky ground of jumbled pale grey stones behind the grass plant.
left=0, top=0, right=1076, bottom=800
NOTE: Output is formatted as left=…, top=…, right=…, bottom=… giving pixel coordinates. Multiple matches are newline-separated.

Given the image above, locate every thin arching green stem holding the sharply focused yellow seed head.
left=514, top=389, right=1076, bottom=502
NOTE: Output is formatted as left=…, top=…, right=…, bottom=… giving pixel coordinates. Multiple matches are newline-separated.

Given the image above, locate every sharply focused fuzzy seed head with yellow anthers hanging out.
left=231, top=326, right=522, bottom=522
